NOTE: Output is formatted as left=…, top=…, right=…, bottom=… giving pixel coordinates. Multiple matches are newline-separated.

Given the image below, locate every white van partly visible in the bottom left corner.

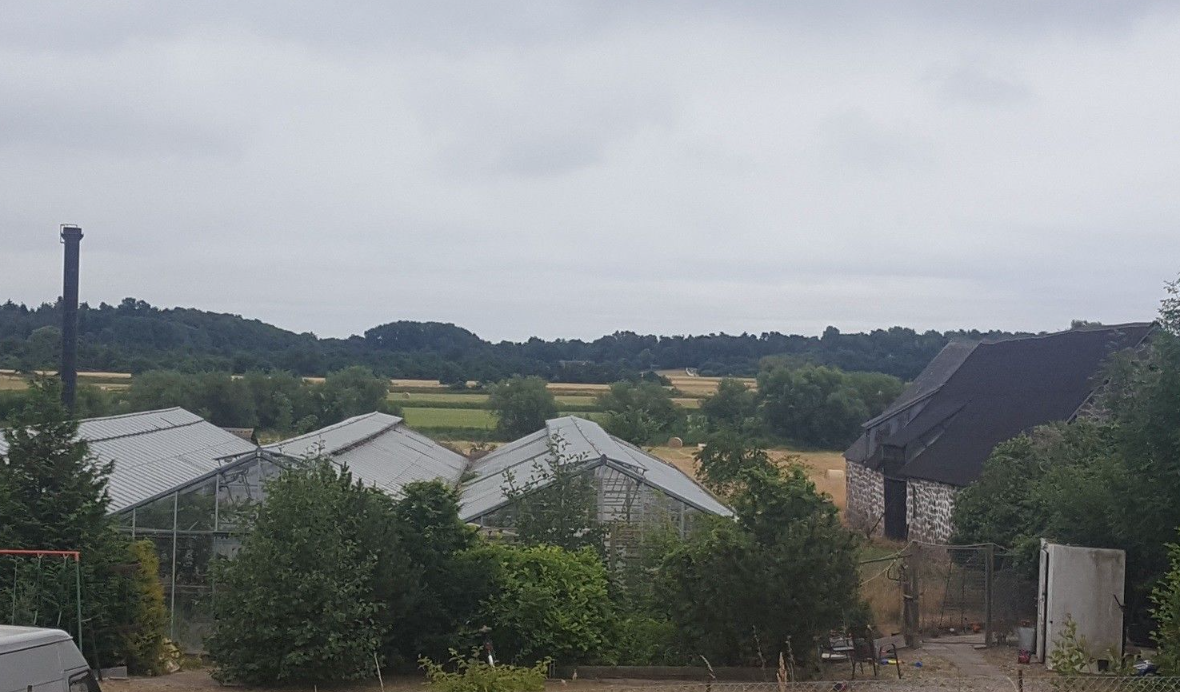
left=0, top=625, right=101, bottom=692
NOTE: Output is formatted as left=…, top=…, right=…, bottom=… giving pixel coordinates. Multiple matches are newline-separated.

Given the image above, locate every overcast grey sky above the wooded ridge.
left=0, top=0, right=1180, bottom=339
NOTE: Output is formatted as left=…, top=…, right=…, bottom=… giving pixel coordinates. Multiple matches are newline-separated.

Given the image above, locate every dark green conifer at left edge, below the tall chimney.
left=0, top=379, right=162, bottom=667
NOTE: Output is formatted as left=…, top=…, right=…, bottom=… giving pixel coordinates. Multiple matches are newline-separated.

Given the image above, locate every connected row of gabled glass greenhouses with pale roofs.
left=18, top=409, right=730, bottom=652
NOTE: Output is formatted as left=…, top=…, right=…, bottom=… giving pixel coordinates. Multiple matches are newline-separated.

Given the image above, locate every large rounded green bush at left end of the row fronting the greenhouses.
left=208, top=459, right=405, bottom=685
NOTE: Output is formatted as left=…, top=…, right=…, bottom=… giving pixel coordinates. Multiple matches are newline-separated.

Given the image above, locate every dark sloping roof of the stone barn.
left=868, top=322, right=1154, bottom=487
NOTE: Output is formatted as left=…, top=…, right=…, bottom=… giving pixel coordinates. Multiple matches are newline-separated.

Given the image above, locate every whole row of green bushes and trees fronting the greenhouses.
left=202, top=427, right=865, bottom=684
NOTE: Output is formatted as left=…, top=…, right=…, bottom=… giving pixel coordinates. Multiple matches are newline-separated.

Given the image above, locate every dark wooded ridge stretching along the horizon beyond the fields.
left=0, top=298, right=1028, bottom=383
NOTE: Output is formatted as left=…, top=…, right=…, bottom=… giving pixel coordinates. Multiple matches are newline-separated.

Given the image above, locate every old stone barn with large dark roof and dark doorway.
left=844, top=322, right=1154, bottom=543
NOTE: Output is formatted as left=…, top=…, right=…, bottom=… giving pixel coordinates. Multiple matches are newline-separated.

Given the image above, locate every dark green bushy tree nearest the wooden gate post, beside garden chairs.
left=656, top=448, right=859, bottom=665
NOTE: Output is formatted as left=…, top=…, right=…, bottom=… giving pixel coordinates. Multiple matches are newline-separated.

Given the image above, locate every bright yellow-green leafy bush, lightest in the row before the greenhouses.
left=465, top=543, right=612, bottom=664
